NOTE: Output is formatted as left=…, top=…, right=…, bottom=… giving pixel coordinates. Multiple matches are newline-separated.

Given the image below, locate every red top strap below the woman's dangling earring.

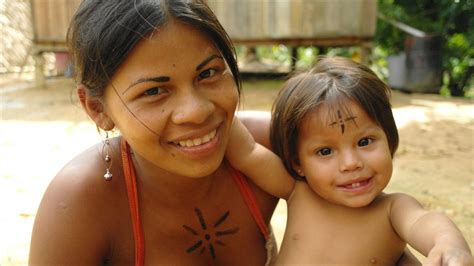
left=120, top=138, right=145, bottom=266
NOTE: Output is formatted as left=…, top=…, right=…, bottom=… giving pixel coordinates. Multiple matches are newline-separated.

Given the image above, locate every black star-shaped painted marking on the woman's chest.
left=183, top=208, right=239, bottom=259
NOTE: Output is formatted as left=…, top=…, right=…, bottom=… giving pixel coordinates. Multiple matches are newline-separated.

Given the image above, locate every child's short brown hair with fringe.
left=270, top=57, right=398, bottom=179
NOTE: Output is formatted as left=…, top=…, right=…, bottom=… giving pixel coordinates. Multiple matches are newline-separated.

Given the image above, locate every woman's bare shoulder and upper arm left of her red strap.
left=30, top=138, right=126, bottom=264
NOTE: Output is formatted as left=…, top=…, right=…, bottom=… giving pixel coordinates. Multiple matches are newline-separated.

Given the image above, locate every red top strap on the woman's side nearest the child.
left=227, top=163, right=270, bottom=240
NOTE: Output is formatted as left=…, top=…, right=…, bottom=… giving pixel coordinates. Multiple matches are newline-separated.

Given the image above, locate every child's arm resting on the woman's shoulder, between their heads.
left=226, top=117, right=295, bottom=199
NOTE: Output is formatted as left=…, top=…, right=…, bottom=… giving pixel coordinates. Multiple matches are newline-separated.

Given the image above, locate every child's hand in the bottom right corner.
left=424, top=246, right=474, bottom=266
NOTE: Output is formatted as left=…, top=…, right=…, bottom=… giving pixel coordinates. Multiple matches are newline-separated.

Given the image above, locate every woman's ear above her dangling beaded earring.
left=77, top=84, right=115, bottom=131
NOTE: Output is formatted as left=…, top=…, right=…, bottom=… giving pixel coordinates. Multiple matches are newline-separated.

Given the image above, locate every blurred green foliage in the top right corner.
left=374, top=0, right=474, bottom=96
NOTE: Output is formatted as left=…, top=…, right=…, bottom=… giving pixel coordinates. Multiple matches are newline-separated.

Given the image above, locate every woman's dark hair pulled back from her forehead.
left=67, top=0, right=241, bottom=97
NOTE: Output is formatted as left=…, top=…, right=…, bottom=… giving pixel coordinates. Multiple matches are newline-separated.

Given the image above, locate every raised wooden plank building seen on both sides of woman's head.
left=30, top=0, right=377, bottom=86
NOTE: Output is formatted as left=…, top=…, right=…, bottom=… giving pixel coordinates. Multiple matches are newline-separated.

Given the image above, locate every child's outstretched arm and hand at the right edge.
left=390, top=194, right=474, bottom=265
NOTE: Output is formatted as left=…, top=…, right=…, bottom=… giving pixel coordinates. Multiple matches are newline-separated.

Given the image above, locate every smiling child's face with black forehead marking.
left=295, top=100, right=392, bottom=207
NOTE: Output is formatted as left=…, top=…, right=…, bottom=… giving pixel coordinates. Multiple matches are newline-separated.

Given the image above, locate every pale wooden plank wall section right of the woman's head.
left=207, top=0, right=377, bottom=67
